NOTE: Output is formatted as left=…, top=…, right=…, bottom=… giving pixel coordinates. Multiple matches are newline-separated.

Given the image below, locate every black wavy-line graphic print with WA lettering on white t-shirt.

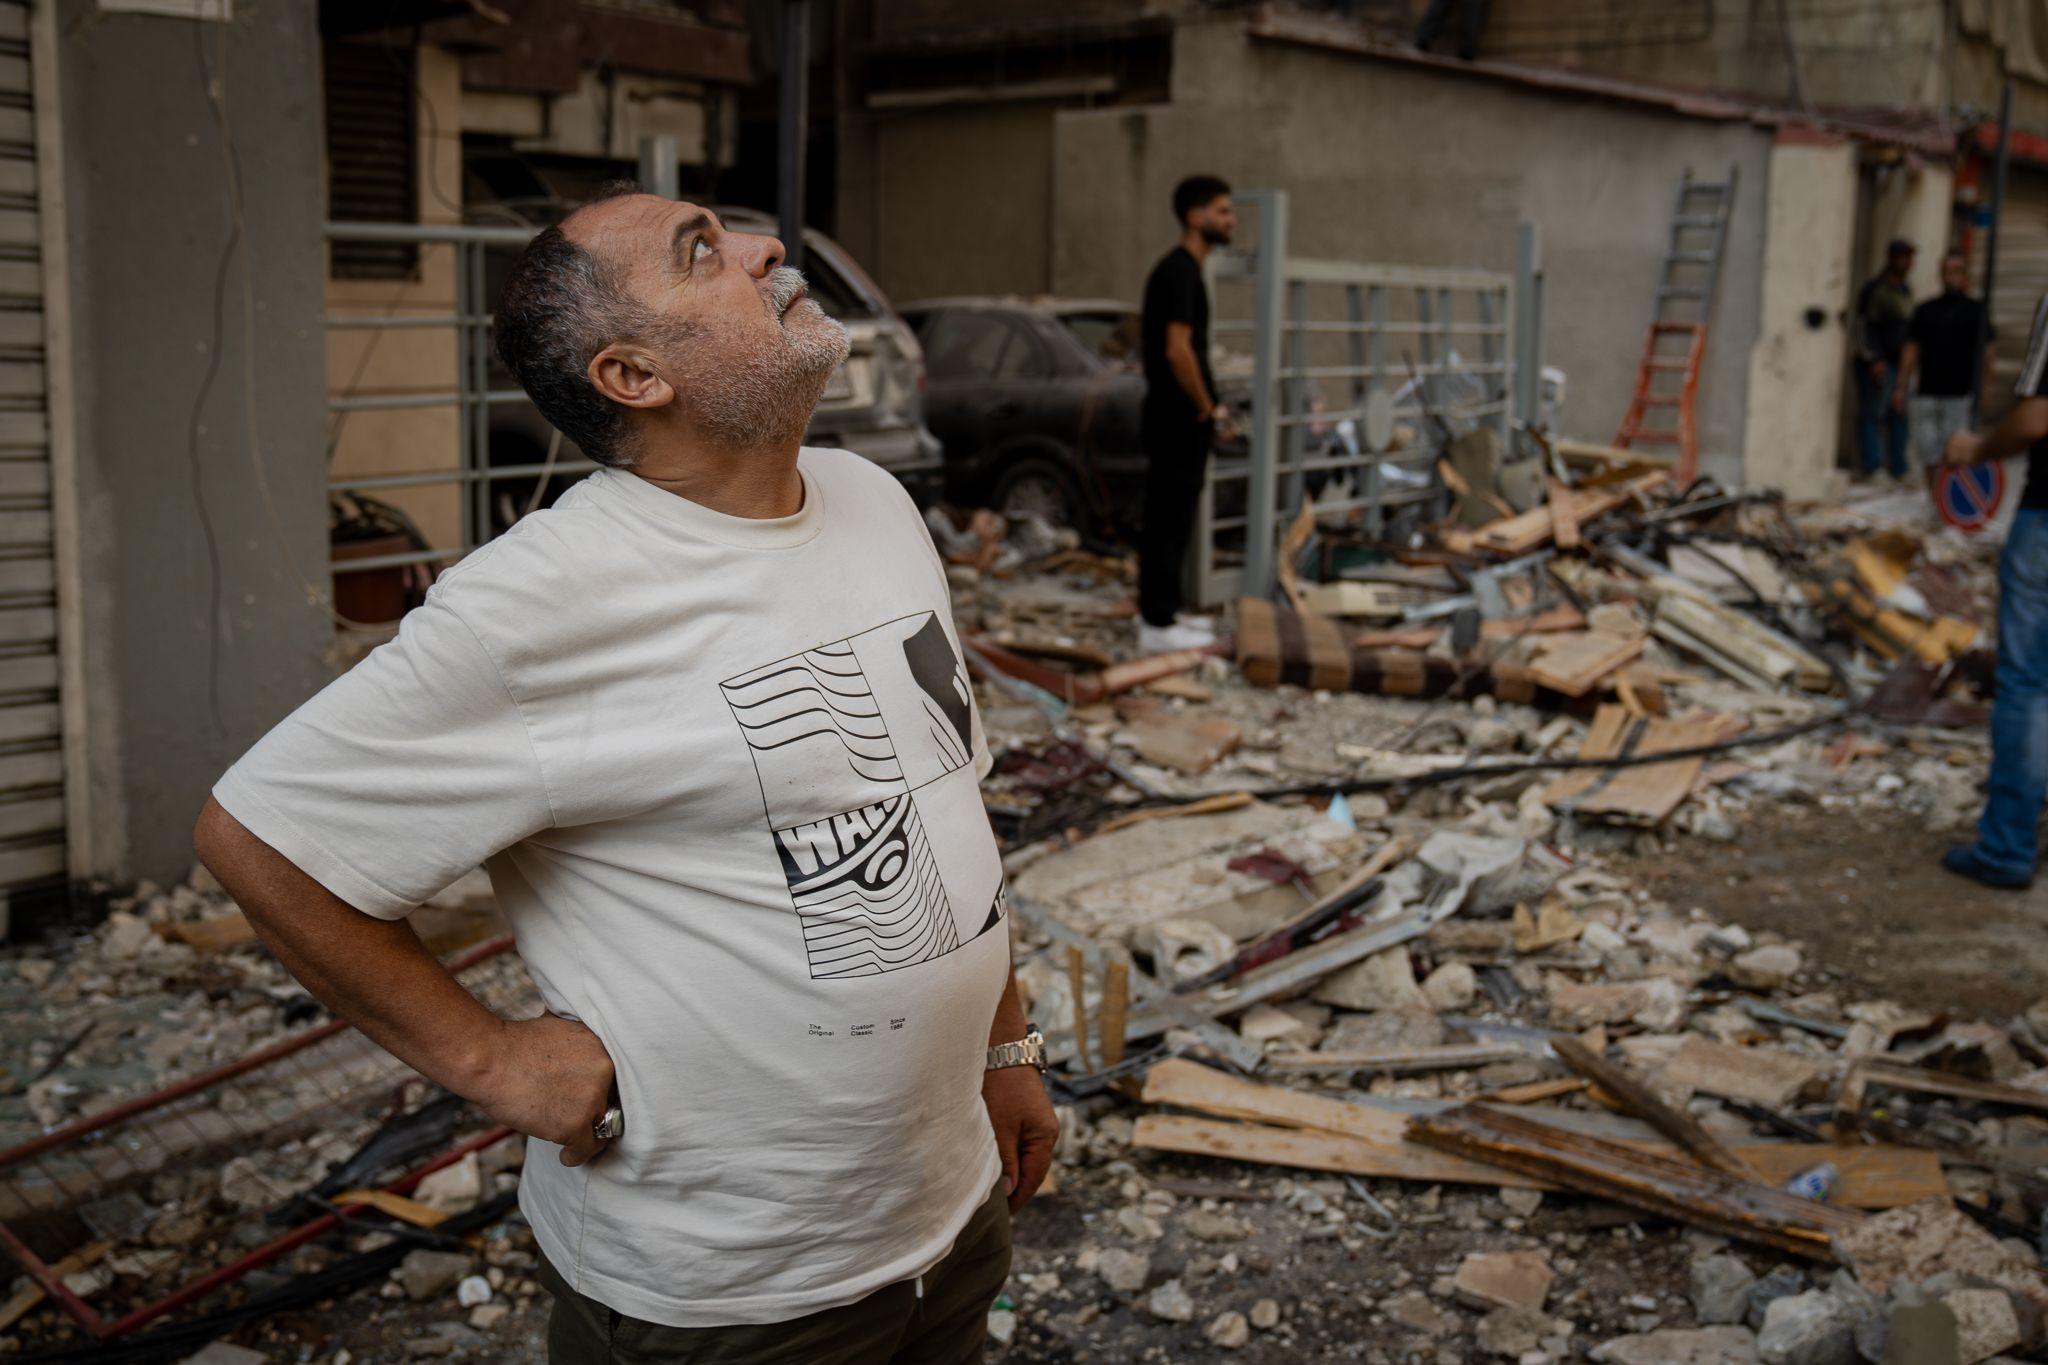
left=719, top=612, right=1004, bottom=976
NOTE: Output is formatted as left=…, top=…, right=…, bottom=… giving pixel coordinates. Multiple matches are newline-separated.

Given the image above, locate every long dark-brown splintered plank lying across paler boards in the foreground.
left=1409, top=1105, right=1864, bottom=1261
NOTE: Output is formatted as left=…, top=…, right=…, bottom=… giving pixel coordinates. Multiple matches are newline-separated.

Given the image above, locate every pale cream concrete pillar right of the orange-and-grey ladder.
left=1743, top=129, right=1855, bottom=497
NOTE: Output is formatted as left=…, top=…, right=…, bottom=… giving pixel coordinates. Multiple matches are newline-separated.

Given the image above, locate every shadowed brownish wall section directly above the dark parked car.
left=838, top=100, right=1055, bottom=303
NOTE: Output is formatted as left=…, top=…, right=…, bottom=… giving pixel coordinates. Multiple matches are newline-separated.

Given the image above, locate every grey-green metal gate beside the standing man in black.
left=1190, top=190, right=1540, bottom=606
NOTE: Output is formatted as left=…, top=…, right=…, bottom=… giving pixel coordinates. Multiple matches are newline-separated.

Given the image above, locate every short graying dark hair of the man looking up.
left=496, top=180, right=645, bottom=469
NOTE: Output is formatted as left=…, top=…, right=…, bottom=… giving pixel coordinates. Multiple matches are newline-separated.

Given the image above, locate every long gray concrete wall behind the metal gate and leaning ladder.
left=1053, top=18, right=1772, bottom=479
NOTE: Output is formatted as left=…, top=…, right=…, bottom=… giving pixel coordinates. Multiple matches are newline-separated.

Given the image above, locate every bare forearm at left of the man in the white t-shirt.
left=195, top=800, right=502, bottom=1099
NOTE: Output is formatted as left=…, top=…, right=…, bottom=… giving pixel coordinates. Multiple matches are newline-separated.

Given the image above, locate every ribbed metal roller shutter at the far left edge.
left=0, top=0, right=66, bottom=923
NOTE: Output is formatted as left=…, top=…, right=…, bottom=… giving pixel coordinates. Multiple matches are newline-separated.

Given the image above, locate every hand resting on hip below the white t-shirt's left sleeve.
left=473, top=1015, right=614, bottom=1166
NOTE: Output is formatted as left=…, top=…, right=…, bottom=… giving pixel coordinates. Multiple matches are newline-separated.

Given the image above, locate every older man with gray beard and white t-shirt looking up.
left=197, top=192, right=1057, bottom=1365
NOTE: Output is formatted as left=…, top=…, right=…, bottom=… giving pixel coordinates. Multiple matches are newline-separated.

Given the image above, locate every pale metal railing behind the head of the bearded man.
left=324, top=223, right=596, bottom=573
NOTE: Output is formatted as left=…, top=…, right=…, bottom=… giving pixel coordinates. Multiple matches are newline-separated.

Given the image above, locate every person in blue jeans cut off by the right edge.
left=1942, top=297, right=2048, bottom=890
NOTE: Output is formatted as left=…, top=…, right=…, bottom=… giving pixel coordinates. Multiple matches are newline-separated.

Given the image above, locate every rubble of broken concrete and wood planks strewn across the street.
left=0, top=464, right=2048, bottom=1365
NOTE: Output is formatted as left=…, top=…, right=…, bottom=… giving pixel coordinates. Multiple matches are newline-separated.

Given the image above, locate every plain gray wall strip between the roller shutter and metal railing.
left=55, top=0, right=330, bottom=878
